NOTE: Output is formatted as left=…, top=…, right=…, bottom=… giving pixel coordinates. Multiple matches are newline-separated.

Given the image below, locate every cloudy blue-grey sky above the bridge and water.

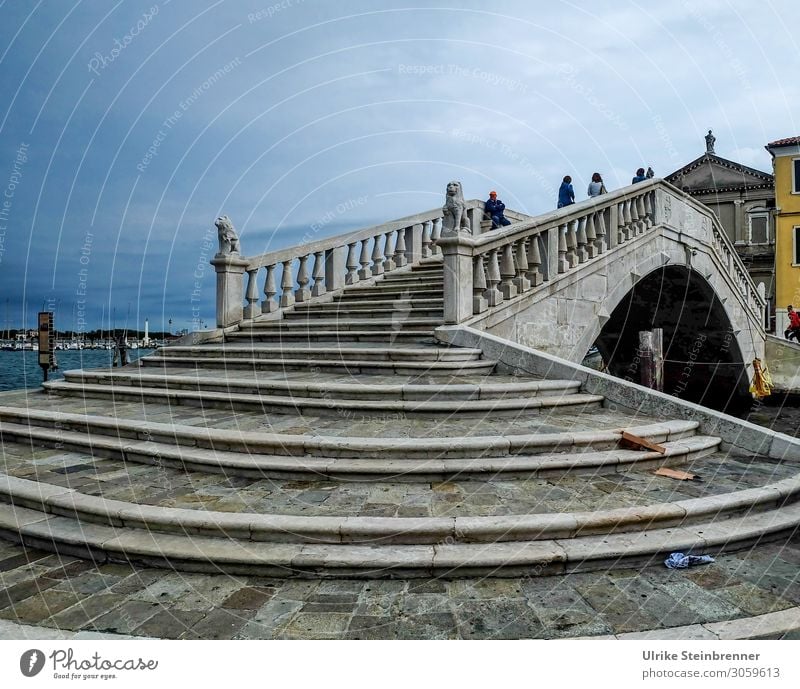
left=0, top=0, right=800, bottom=329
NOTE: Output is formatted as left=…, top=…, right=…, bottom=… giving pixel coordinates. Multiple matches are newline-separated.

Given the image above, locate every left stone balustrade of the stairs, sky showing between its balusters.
left=211, top=199, right=484, bottom=328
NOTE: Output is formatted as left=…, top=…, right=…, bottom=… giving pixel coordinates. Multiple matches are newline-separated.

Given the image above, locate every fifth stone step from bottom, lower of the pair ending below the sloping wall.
left=43, top=377, right=603, bottom=418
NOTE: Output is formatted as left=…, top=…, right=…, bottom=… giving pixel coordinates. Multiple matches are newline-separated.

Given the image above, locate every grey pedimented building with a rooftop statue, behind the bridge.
left=665, top=130, right=775, bottom=330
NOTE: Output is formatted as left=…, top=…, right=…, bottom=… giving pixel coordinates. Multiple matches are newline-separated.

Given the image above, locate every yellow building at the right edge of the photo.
left=766, top=136, right=800, bottom=337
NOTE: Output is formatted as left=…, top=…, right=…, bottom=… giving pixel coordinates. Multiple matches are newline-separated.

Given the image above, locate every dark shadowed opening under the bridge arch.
left=595, top=265, right=752, bottom=415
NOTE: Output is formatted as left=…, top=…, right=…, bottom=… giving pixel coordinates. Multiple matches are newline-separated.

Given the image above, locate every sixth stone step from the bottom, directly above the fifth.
left=57, top=369, right=580, bottom=401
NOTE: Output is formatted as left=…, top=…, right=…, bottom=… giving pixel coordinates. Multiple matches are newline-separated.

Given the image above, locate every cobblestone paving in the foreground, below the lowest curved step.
left=0, top=536, right=800, bottom=639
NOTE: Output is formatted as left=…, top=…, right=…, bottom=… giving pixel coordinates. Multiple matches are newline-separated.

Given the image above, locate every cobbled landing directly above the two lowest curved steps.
left=0, top=443, right=797, bottom=517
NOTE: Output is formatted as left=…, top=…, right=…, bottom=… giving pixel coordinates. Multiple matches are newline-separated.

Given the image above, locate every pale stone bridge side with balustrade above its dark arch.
left=439, top=180, right=765, bottom=409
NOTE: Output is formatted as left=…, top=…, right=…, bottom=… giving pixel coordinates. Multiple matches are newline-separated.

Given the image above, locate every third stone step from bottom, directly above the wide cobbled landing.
left=0, top=419, right=720, bottom=485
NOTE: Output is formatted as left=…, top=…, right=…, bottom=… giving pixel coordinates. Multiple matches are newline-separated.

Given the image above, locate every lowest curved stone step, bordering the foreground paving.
left=0, top=484, right=800, bottom=578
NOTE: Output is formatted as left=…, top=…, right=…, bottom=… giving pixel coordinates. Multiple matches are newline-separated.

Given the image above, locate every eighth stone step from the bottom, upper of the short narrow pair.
left=150, top=343, right=482, bottom=363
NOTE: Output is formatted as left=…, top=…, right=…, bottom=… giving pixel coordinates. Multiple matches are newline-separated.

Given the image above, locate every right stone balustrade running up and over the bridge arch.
left=439, top=179, right=764, bottom=324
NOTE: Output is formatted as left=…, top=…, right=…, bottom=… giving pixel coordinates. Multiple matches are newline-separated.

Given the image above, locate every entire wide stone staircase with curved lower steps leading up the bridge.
left=0, top=259, right=800, bottom=577
